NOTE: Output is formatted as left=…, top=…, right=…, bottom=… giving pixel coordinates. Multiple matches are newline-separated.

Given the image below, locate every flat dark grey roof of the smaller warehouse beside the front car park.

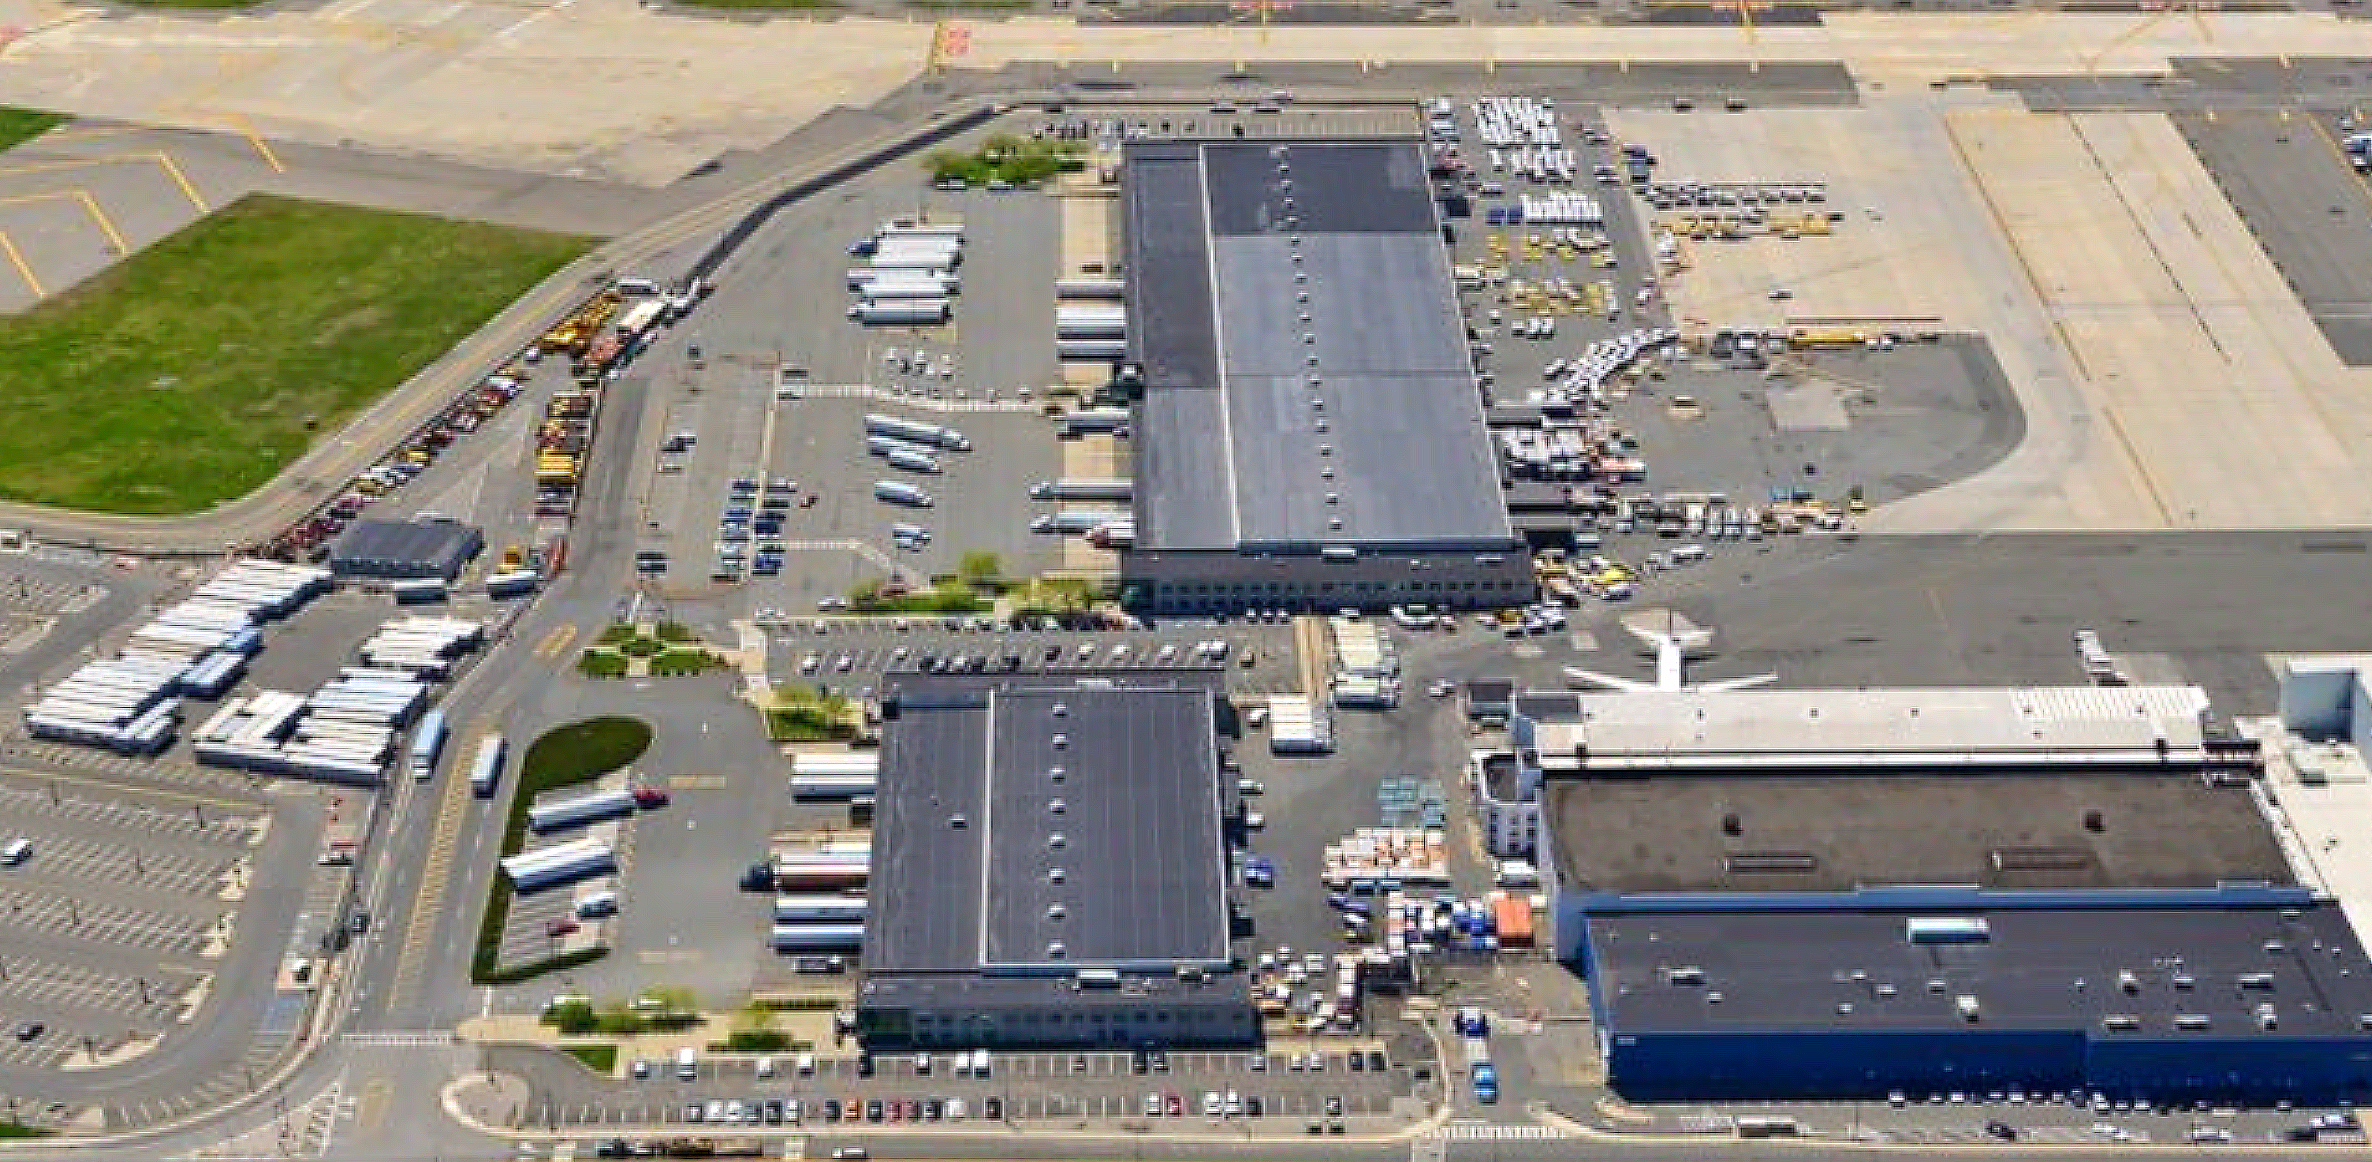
left=866, top=671, right=1229, bottom=975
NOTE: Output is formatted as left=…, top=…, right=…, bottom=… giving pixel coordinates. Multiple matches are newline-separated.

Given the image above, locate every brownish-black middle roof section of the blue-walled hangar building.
left=1542, top=768, right=2294, bottom=894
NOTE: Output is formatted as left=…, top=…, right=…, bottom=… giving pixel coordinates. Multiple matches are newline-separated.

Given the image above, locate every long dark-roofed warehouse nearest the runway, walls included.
left=1122, top=142, right=1532, bottom=612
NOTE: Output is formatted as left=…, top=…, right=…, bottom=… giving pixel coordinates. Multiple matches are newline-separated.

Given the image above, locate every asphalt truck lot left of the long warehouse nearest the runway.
left=636, top=142, right=1081, bottom=609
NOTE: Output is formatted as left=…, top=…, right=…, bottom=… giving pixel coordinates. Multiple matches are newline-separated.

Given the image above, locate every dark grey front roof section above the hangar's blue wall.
left=1589, top=906, right=2372, bottom=1041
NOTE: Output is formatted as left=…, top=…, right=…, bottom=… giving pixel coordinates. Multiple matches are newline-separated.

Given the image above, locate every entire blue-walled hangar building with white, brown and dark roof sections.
left=1506, top=688, right=2372, bottom=1100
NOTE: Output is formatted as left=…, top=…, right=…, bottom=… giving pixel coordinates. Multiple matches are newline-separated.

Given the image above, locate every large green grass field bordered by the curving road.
left=0, top=197, right=593, bottom=515
